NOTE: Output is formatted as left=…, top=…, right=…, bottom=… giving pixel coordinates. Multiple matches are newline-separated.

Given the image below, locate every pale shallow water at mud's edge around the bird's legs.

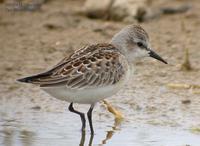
left=0, top=103, right=200, bottom=146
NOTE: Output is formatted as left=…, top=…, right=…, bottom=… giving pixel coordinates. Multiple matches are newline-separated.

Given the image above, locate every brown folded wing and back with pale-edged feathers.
left=19, top=44, right=126, bottom=89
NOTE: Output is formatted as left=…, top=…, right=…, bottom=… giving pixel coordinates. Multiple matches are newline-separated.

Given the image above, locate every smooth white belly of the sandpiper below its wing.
left=42, top=83, right=123, bottom=104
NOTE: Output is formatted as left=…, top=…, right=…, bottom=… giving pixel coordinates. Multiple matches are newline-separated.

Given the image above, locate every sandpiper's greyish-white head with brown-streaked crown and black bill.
left=111, top=25, right=167, bottom=64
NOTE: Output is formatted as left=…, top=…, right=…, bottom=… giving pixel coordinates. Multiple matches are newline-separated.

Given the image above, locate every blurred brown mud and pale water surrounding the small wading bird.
left=0, top=0, right=200, bottom=146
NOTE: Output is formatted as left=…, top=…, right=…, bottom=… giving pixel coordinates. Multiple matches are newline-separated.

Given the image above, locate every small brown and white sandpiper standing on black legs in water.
left=18, top=24, right=167, bottom=134
